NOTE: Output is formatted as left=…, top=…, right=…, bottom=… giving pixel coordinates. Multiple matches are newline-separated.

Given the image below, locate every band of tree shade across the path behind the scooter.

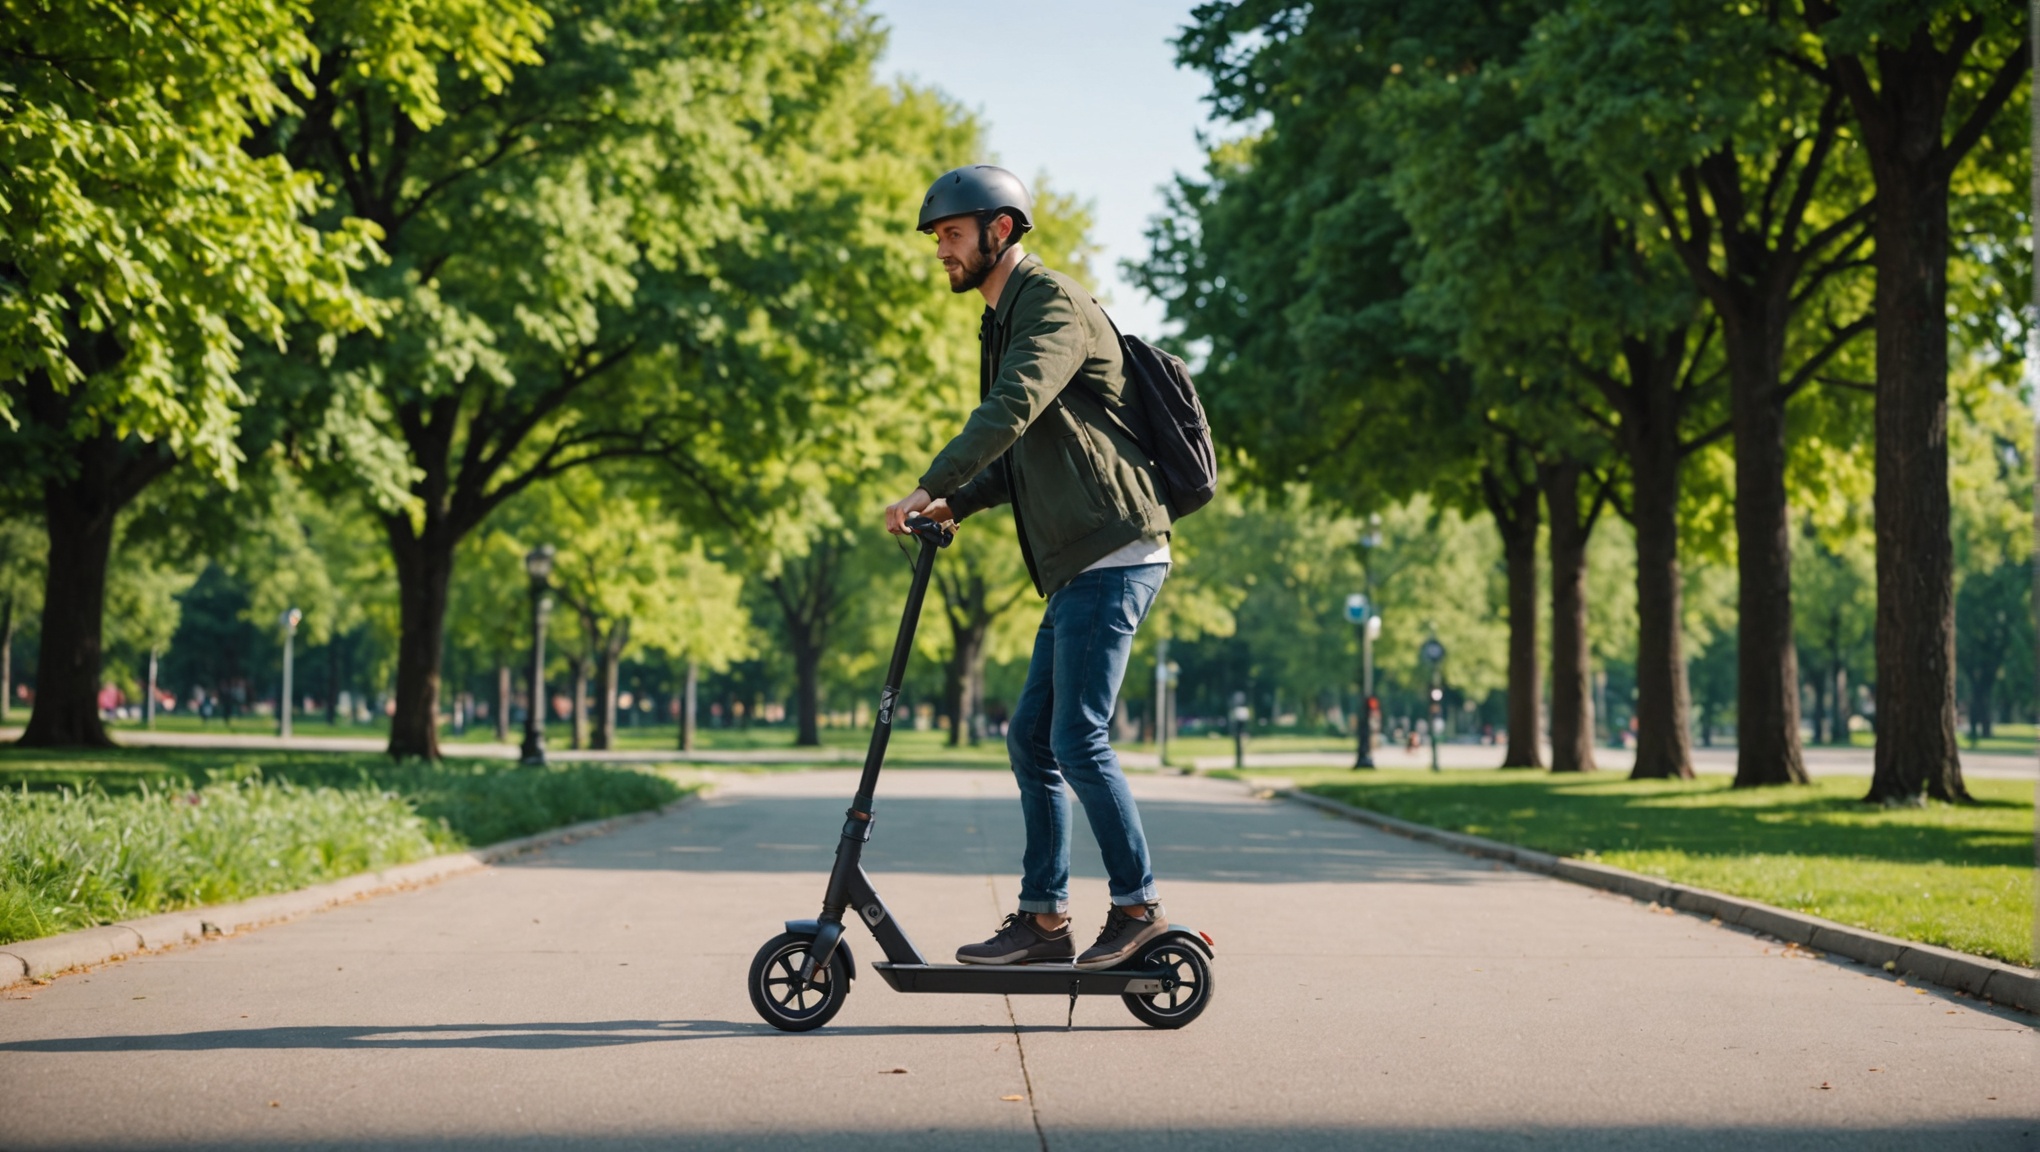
left=500, top=795, right=1497, bottom=885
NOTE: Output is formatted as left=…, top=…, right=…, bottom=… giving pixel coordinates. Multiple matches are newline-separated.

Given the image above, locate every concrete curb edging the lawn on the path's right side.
left=1277, top=789, right=2040, bottom=1013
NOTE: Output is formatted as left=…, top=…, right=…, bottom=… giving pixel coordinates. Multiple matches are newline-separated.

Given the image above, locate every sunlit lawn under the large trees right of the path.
left=1291, top=771, right=2034, bottom=964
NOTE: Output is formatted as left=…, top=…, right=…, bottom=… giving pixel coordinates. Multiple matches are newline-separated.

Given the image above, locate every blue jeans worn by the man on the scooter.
left=1006, top=565, right=1169, bottom=911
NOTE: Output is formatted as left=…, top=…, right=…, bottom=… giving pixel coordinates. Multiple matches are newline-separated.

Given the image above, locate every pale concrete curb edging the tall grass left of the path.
left=0, top=789, right=706, bottom=989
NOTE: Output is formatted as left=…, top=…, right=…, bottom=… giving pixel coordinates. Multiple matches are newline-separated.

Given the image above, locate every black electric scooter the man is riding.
left=749, top=516, right=1214, bottom=1032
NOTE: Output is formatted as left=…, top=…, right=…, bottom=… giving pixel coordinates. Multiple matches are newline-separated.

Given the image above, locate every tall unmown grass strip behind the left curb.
left=0, top=748, right=685, bottom=944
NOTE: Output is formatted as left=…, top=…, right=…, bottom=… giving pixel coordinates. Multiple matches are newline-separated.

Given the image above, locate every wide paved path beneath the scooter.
left=0, top=771, right=2040, bottom=1152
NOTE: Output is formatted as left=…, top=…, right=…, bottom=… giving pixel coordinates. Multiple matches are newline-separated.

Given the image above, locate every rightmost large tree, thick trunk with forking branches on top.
left=1791, top=0, right=2030, bottom=803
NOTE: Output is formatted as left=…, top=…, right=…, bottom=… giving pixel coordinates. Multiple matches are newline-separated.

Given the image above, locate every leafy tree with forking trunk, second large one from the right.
left=1526, top=0, right=1873, bottom=787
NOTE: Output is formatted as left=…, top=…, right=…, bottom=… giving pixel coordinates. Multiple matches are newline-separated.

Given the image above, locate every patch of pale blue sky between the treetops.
left=867, top=0, right=1208, bottom=336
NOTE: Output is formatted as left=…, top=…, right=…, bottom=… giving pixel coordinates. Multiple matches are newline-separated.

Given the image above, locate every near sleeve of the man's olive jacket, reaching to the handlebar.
left=920, top=275, right=1091, bottom=495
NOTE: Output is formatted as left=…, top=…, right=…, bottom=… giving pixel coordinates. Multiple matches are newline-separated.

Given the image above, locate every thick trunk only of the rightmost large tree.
left=1858, top=49, right=1969, bottom=803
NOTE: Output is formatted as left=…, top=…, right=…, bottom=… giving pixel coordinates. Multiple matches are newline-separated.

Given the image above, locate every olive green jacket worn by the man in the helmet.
left=920, top=255, right=1171, bottom=595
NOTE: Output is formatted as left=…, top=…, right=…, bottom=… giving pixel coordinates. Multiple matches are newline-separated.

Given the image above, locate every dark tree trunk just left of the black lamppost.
left=384, top=514, right=457, bottom=761
